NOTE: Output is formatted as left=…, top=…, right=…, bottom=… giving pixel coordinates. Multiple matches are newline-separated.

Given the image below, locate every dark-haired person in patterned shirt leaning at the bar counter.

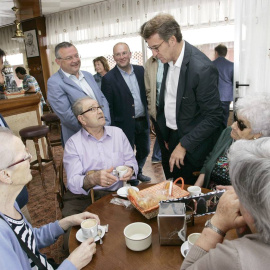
left=15, top=67, right=46, bottom=112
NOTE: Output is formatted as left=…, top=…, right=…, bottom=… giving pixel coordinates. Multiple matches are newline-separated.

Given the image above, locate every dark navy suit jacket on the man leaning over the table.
left=157, top=41, right=224, bottom=167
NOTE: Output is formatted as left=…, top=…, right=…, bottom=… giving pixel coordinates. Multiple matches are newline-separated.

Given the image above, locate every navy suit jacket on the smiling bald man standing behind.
left=101, top=65, right=149, bottom=147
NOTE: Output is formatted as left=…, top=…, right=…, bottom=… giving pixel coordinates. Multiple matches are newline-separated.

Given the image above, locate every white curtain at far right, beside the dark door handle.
left=235, top=0, right=270, bottom=97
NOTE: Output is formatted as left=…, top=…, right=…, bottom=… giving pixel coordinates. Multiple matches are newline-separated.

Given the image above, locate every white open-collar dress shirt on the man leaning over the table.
left=164, top=41, right=185, bottom=130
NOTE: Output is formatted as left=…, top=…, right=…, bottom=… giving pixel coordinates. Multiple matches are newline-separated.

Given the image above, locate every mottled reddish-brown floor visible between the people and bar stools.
left=28, top=130, right=165, bottom=263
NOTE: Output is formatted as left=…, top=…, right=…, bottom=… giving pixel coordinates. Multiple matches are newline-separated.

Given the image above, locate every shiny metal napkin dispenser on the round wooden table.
left=157, top=202, right=187, bottom=246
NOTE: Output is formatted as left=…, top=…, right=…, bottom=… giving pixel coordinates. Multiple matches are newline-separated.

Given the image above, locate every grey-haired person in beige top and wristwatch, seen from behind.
left=181, top=138, right=270, bottom=270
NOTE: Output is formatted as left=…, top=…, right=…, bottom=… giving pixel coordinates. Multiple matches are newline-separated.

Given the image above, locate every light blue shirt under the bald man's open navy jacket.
left=117, top=65, right=145, bottom=118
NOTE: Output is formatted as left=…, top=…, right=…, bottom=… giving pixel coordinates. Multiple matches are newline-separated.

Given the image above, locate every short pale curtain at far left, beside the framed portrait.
left=0, top=24, right=25, bottom=55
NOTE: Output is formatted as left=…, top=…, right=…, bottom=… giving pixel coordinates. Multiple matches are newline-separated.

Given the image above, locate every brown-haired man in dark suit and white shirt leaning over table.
left=141, top=14, right=223, bottom=184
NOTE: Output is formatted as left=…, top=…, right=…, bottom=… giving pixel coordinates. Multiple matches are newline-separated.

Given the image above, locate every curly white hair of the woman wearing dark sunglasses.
left=235, top=93, right=270, bottom=137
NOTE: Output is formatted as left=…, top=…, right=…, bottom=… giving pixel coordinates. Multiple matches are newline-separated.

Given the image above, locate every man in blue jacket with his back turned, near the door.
left=213, top=44, right=233, bottom=126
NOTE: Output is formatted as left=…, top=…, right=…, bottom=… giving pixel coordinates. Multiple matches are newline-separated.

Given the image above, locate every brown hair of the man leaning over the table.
left=140, top=13, right=182, bottom=43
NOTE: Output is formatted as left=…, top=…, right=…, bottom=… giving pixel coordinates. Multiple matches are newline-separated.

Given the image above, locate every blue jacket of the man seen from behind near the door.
left=213, top=57, right=233, bottom=101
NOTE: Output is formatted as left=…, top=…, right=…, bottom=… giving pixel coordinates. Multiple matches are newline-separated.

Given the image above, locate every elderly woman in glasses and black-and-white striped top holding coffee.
left=0, top=127, right=99, bottom=270
